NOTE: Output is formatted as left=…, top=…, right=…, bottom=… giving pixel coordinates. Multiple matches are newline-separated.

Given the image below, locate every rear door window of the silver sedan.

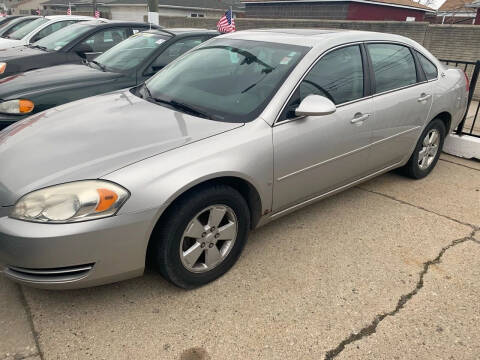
left=367, top=44, right=417, bottom=93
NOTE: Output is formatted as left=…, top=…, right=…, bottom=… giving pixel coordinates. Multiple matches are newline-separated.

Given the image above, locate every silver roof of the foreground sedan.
left=221, top=29, right=418, bottom=47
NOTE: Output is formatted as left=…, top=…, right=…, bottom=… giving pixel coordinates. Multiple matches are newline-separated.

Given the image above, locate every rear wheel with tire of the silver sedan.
left=402, top=119, right=446, bottom=179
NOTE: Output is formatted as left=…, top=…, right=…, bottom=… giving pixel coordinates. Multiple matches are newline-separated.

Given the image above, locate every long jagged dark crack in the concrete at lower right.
left=325, top=229, right=477, bottom=360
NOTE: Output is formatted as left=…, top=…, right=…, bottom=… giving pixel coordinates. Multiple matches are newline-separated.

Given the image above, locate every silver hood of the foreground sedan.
left=0, top=90, right=243, bottom=206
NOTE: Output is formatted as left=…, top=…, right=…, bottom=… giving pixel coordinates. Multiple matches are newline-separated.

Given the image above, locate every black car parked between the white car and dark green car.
left=0, top=20, right=161, bottom=78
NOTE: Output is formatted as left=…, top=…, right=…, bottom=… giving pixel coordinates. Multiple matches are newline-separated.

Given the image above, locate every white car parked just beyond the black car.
left=0, top=15, right=108, bottom=49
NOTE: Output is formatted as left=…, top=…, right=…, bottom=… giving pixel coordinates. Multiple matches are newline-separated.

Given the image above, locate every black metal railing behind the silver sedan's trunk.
left=440, top=59, right=480, bottom=137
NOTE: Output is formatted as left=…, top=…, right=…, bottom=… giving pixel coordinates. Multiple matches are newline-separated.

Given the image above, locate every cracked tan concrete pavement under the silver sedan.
left=0, top=155, right=480, bottom=360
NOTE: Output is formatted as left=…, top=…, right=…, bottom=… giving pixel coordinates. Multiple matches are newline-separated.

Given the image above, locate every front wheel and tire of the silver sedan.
left=149, top=184, right=250, bottom=289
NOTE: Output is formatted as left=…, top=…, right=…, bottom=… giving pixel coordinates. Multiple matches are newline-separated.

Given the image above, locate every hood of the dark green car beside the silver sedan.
left=0, top=64, right=125, bottom=100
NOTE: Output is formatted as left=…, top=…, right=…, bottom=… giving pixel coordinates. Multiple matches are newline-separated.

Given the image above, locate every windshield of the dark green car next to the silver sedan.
left=95, top=33, right=170, bottom=72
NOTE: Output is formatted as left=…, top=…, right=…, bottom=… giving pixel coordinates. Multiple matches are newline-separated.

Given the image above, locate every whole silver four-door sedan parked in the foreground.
left=0, top=30, right=468, bottom=289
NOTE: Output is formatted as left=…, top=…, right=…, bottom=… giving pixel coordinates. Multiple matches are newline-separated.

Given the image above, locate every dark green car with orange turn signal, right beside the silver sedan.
left=0, top=29, right=218, bottom=129
